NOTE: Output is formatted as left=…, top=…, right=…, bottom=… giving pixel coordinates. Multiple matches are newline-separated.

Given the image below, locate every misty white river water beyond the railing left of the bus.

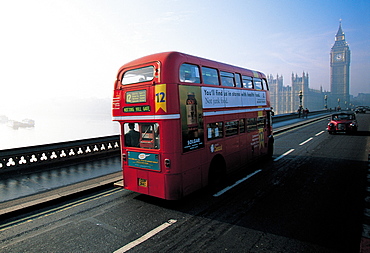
left=0, top=112, right=120, bottom=150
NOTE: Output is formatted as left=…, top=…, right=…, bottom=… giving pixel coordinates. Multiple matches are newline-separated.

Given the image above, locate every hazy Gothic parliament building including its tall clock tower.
left=268, top=23, right=366, bottom=114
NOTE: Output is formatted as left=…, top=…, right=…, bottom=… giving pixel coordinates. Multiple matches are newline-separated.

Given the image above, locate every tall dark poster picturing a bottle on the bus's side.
left=179, top=85, right=204, bottom=153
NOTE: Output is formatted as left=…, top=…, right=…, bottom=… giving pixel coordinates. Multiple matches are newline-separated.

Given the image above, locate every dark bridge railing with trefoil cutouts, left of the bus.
left=0, top=135, right=120, bottom=173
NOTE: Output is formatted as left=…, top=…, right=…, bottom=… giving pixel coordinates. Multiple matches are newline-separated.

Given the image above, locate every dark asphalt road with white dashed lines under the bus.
left=0, top=114, right=370, bottom=252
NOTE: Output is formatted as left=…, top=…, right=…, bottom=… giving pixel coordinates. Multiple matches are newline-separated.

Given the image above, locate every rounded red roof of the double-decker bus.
left=119, top=51, right=266, bottom=79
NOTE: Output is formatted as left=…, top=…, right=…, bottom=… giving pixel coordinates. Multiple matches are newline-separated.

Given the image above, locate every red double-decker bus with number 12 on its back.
left=112, top=52, right=273, bottom=200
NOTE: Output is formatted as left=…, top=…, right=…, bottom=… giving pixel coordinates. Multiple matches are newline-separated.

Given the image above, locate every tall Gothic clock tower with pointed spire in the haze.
left=330, top=22, right=351, bottom=108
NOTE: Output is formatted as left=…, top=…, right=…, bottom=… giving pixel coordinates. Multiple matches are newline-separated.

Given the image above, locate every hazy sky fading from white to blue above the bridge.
left=0, top=0, right=370, bottom=114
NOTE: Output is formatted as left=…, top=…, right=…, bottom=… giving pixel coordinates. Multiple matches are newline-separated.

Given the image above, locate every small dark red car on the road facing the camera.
left=327, top=112, right=358, bottom=134
